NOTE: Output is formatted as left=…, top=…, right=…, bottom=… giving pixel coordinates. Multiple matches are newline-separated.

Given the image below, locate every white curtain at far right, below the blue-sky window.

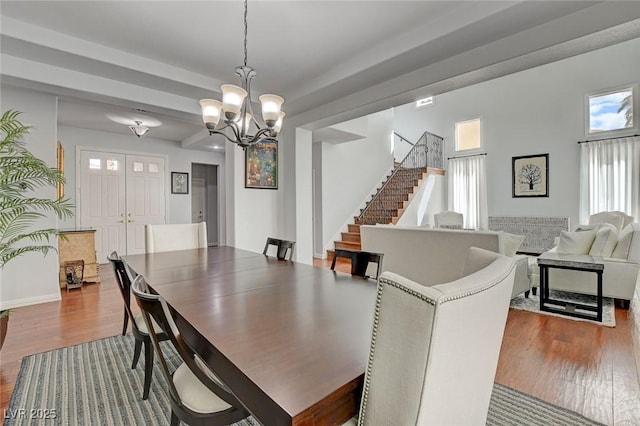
left=580, top=136, right=640, bottom=223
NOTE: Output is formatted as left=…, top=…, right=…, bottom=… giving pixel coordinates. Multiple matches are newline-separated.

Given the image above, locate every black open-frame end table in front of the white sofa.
left=538, top=253, right=604, bottom=322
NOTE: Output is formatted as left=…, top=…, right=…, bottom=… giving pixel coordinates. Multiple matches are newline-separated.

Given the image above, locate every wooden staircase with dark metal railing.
left=327, top=132, right=443, bottom=260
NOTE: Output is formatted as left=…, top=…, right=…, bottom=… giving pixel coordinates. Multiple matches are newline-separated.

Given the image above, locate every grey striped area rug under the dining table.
left=4, top=335, right=599, bottom=426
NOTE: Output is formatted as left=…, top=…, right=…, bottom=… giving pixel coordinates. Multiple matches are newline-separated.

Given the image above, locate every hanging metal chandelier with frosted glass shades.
left=200, top=0, right=285, bottom=150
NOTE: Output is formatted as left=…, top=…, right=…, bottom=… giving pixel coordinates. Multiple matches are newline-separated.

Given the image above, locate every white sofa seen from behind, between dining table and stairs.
left=360, top=225, right=530, bottom=297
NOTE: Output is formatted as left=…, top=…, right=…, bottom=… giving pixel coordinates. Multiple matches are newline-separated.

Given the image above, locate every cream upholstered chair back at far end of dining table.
left=145, top=222, right=207, bottom=253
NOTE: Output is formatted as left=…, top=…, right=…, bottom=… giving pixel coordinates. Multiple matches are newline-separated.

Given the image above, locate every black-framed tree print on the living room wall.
left=511, top=154, right=549, bottom=198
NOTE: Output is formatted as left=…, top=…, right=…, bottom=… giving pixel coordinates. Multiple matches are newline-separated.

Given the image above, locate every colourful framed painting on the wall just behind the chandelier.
left=244, top=142, right=278, bottom=189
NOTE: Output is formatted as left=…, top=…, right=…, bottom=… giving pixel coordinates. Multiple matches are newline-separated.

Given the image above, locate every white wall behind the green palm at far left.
left=0, top=86, right=60, bottom=310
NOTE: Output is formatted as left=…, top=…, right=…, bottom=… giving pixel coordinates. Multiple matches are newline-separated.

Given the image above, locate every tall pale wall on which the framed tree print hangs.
left=395, top=39, right=640, bottom=225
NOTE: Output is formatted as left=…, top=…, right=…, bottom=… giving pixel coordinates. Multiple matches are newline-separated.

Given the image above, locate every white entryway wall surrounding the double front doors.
left=58, top=126, right=225, bottom=228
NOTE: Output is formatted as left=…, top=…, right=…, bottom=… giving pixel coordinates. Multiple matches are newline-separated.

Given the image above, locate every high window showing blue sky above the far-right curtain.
left=587, top=86, right=638, bottom=135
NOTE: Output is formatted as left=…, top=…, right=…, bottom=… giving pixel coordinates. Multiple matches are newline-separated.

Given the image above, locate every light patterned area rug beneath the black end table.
left=511, top=290, right=616, bottom=327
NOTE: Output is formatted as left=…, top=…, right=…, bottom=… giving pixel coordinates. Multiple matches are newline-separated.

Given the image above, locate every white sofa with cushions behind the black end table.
left=529, top=223, right=640, bottom=308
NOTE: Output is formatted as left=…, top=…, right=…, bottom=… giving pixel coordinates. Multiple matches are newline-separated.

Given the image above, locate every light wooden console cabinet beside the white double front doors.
left=58, top=229, right=100, bottom=288
